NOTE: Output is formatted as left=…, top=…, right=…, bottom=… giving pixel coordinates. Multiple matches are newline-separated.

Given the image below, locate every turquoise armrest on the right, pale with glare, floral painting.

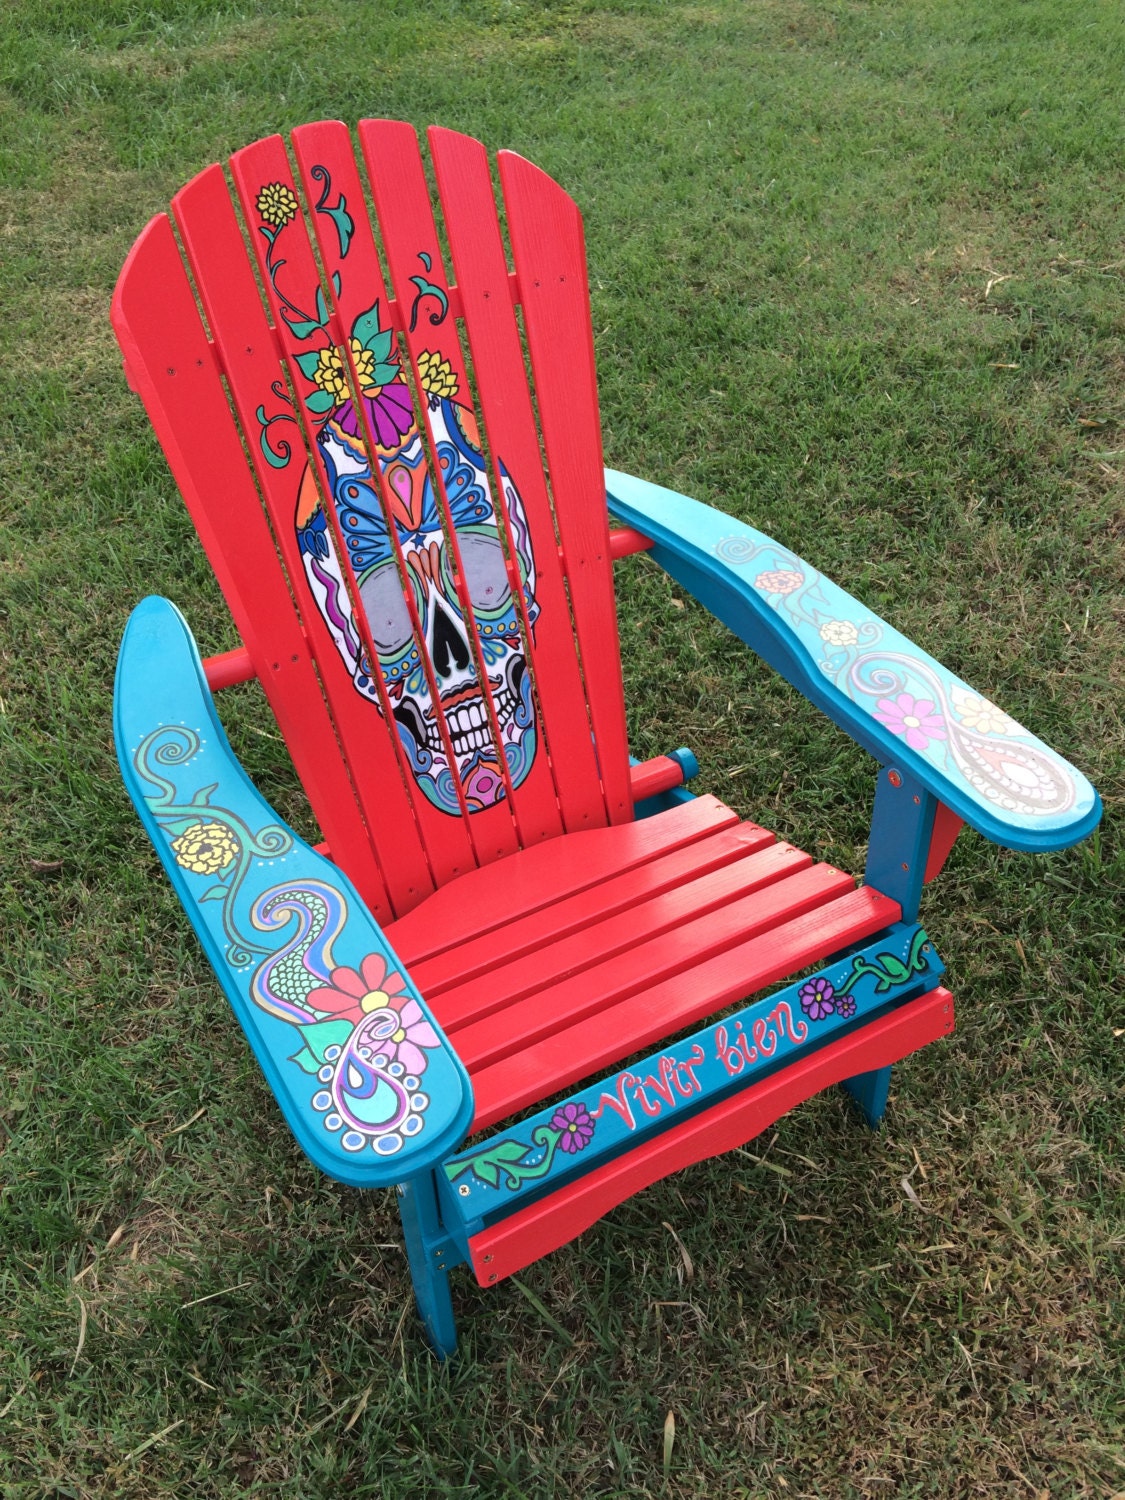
left=606, top=470, right=1101, bottom=849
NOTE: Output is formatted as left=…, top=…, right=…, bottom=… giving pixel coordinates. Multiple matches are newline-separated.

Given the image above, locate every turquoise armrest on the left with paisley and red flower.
left=114, top=597, right=473, bottom=1188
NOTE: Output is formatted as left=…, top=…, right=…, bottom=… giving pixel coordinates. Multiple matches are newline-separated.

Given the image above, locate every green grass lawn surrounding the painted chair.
left=0, top=0, right=1125, bottom=1500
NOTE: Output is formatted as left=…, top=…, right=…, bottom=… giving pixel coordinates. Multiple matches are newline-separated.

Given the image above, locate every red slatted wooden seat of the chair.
left=387, top=797, right=900, bottom=1131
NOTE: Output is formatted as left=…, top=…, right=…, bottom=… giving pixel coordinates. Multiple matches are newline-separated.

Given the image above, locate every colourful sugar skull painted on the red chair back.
left=297, top=367, right=539, bottom=815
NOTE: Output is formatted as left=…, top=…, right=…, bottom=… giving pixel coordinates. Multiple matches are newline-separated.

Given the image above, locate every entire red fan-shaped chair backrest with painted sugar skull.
left=111, top=120, right=633, bottom=918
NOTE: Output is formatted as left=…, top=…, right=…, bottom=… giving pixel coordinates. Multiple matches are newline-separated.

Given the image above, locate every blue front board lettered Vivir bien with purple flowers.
left=438, top=923, right=944, bottom=1244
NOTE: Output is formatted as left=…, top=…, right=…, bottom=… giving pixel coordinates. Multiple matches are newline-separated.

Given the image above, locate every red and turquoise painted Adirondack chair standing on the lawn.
left=113, top=120, right=1100, bottom=1356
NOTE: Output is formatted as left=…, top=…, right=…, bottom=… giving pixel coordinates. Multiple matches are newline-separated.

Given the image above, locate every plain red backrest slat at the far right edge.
left=498, top=152, right=633, bottom=822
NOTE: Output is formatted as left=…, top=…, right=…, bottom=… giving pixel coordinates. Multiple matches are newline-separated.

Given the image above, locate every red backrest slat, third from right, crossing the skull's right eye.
left=343, top=120, right=563, bottom=846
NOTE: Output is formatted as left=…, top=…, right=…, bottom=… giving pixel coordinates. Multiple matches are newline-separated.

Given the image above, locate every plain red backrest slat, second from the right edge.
left=429, top=128, right=606, bottom=833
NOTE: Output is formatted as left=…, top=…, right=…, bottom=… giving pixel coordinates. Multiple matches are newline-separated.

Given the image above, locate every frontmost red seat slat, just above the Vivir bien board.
left=468, top=867, right=900, bottom=1131
